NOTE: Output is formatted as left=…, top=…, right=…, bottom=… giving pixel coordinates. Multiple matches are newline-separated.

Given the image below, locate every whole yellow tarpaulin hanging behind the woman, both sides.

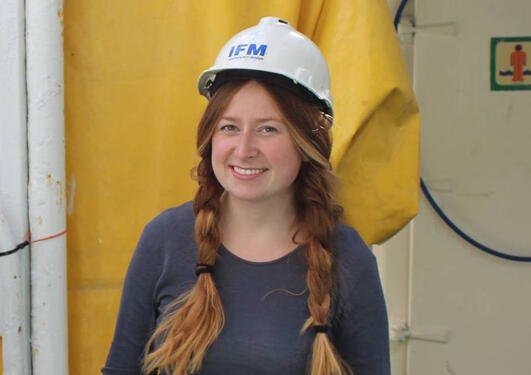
left=64, top=0, right=419, bottom=374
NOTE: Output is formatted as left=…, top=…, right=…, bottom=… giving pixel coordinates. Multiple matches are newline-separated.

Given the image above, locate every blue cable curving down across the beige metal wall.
left=394, top=0, right=531, bottom=262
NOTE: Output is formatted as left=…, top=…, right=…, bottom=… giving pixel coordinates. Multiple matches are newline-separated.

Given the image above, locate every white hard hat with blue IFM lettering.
left=198, top=17, right=333, bottom=116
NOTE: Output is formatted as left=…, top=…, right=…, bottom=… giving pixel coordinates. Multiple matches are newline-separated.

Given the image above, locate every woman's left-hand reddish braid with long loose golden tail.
left=143, top=159, right=225, bottom=375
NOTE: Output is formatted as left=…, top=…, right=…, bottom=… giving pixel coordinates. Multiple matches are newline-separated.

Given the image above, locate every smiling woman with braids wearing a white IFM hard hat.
left=103, top=17, right=389, bottom=375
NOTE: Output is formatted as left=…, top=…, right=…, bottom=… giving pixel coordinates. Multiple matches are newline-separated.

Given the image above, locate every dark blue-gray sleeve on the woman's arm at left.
left=101, top=225, right=162, bottom=375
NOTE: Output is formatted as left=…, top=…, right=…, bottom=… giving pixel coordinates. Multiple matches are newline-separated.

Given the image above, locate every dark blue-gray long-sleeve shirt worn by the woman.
left=102, top=203, right=390, bottom=375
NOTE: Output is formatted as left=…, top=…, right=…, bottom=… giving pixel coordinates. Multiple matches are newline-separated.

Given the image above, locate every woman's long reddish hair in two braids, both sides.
left=143, top=80, right=351, bottom=375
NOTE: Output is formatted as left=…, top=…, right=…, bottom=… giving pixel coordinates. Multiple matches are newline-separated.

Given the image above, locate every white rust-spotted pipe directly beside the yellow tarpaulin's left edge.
left=26, top=0, right=68, bottom=375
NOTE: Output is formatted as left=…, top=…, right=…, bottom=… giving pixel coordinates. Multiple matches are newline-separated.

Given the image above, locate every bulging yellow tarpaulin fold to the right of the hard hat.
left=314, top=0, right=419, bottom=244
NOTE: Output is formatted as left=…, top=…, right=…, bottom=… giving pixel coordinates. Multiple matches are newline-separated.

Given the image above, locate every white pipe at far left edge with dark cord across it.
left=0, top=0, right=31, bottom=375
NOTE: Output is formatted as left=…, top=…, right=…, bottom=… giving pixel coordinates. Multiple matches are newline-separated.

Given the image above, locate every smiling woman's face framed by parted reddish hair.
left=212, top=81, right=302, bottom=206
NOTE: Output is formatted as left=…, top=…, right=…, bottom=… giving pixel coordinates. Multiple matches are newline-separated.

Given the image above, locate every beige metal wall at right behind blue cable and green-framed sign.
left=377, top=0, right=531, bottom=375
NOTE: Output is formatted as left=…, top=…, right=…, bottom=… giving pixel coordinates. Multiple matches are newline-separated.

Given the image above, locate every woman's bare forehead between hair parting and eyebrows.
left=223, top=81, right=284, bottom=119
